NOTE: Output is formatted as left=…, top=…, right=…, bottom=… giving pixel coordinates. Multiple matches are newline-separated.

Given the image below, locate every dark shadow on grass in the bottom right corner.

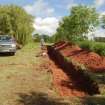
left=82, top=96, right=105, bottom=105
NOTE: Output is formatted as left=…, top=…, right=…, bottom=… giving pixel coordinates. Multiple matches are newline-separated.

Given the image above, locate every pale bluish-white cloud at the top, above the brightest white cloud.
left=23, top=0, right=55, bottom=17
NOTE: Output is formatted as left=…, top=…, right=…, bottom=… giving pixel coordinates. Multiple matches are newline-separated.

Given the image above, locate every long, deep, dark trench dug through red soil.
left=47, top=41, right=100, bottom=95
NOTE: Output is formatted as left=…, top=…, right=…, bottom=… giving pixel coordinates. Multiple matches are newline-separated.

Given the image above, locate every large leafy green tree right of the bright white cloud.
left=55, top=5, right=98, bottom=41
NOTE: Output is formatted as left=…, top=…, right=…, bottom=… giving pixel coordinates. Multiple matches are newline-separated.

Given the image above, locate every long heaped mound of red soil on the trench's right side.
left=56, top=42, right=105, bottom=72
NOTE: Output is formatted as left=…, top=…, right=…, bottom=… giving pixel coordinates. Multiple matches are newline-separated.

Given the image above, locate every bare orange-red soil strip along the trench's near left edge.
left=49, top=60, right=87, bottom=97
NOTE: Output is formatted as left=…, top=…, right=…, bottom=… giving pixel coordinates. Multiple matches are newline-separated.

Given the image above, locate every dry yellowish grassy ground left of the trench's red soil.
left=0, top=44, right=68, bottom=105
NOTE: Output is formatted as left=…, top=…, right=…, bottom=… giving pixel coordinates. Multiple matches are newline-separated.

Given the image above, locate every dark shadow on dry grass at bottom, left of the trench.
left=18, top=92, right=70, bottom=105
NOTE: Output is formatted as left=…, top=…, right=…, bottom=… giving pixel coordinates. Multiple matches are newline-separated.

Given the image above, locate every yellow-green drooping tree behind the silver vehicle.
left=0, top=5, right=33, bottom=45
